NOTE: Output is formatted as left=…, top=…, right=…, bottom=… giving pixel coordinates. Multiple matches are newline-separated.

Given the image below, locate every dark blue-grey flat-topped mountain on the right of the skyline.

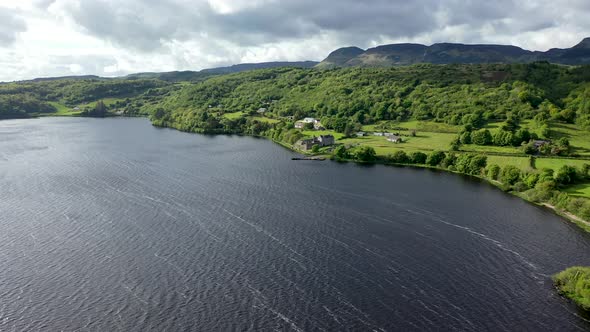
left=316, top=38, right=590, bottom=68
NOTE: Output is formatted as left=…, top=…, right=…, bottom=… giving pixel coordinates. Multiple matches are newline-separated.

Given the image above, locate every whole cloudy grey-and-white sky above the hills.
left=0, top=0, right=590, bottom=81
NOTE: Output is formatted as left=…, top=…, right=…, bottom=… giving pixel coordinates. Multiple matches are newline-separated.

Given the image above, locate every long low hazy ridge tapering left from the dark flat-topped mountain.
left=124, top=61, right=318, bottom=82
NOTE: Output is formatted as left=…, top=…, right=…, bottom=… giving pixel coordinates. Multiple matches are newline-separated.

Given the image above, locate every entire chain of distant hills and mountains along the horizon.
left=9, top=37, right=590, bottom=83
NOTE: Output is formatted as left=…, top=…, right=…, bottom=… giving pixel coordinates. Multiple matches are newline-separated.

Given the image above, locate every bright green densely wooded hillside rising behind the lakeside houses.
left=151, top=63, right=590, bottom=132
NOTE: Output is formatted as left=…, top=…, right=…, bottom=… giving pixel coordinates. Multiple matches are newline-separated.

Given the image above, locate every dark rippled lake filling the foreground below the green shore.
left=0, top=118, right=590, bottom=331
